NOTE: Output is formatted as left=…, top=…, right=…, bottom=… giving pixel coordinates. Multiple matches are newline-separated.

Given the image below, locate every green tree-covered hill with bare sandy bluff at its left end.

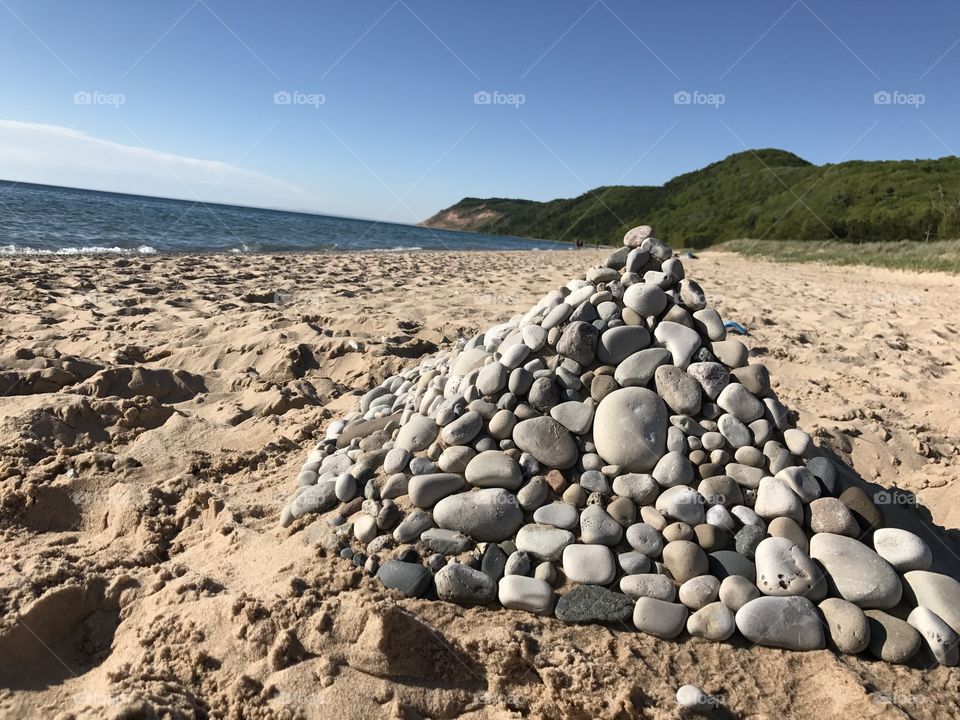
left=423, top=149, right=960, bottom=247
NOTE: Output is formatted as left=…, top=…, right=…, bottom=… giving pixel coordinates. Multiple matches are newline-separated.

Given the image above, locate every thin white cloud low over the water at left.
left=0, top=120, right=314, bottom=208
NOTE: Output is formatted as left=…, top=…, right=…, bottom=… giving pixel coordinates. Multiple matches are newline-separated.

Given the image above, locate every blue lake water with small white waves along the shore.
left=0, top=181, right=570, bottom=254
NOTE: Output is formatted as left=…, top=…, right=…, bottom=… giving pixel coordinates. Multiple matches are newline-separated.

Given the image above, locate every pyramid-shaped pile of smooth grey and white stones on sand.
left=281, top=226, right=960, bottom=665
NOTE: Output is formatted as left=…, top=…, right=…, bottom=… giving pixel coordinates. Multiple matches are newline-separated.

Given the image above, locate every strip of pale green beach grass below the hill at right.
left=714, top=240, right=960, bottom=273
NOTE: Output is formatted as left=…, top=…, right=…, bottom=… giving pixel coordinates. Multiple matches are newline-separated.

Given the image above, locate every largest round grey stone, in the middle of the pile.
left=592, top=387, right=669, bottom=472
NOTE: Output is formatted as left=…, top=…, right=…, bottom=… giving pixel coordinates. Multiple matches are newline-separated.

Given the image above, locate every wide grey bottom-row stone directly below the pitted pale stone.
left=736, top=596, right=826, bottom=650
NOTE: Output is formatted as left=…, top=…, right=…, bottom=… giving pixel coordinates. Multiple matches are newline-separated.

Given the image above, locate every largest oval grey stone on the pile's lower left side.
left=433, top=488, right=523, bottom=542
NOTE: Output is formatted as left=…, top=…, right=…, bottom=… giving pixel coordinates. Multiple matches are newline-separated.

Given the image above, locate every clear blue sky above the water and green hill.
left=0, top=0, right=960, bottom=223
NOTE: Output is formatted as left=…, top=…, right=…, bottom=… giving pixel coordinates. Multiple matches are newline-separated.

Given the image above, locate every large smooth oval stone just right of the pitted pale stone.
left=810, top=533, right=902, bottom=609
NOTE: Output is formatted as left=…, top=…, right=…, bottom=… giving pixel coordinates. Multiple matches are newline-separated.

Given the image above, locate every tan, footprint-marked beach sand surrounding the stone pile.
left=0, top=250, right=960, bottom=720
